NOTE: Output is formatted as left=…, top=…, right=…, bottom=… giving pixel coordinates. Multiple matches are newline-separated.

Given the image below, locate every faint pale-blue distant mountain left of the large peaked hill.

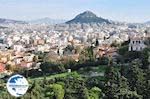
left=29, top=17, right=66, bottom=24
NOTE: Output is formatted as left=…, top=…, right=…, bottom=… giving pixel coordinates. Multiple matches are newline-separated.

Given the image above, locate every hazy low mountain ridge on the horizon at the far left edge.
left=0, top=18, right=26, bottom=24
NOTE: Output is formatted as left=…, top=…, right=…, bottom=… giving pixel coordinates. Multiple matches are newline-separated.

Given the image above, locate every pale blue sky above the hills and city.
left=0, top=0, right=150, bottom=22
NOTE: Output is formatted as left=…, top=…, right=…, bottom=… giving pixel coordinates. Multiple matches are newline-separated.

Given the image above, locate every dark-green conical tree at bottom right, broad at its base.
left=104, top=67, right=141, bottom=99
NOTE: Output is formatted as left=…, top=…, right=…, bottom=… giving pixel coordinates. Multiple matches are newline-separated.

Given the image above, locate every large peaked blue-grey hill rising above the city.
left=66, top=11, right=111, bottom=24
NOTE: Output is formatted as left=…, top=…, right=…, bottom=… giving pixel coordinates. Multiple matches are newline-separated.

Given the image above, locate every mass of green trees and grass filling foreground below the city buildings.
left=0, top=45, right=150, bottom=99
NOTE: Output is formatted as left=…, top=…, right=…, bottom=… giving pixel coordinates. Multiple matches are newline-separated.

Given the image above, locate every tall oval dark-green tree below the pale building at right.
left=127, top=60, right=146, bottom=95
